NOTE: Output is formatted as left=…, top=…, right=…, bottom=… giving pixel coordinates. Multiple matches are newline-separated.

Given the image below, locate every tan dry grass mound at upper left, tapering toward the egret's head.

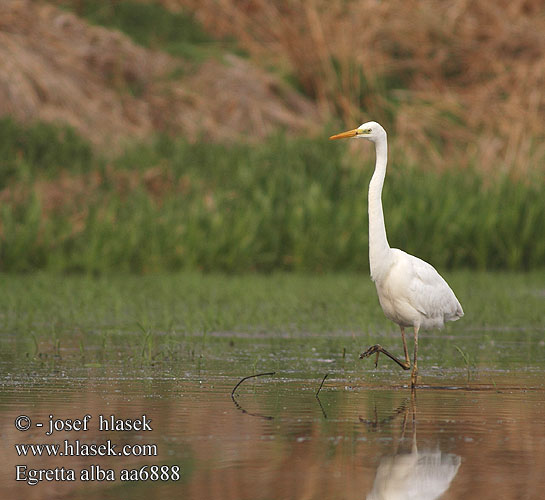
left=0, top=0, right=317, bottom=146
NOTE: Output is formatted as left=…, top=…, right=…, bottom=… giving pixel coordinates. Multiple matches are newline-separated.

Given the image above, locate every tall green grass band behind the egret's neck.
left=0, top=120, right=545, bottom=274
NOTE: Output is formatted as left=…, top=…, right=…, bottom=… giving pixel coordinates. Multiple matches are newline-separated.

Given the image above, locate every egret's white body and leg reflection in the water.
left=360, top=393, right=461, bottom=500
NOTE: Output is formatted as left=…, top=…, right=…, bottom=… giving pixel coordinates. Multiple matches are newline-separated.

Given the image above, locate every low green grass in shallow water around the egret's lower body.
left=0, top=272, right=545, bottom=373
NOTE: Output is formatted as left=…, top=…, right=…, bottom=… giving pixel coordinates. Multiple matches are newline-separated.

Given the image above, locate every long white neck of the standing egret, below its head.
left=368, top=134, right=390, bottom=281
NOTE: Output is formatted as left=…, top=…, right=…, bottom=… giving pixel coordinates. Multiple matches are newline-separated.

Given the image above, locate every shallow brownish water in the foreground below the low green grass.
left=0, top=332, right=545, bottom=500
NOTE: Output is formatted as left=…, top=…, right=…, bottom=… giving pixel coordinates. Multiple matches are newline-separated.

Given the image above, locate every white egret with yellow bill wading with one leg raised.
left=330, top=122, right=464, bottom=387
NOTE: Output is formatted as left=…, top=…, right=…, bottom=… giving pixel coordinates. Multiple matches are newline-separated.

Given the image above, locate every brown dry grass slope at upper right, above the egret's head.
left=170, top=0, right=545, bottom=172
